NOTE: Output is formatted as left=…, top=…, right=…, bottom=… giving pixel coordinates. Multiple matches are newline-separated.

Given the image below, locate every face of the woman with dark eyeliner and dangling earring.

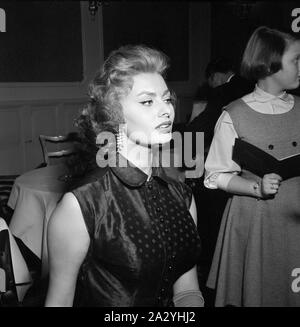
left=120, top=73, right=174, bottom=146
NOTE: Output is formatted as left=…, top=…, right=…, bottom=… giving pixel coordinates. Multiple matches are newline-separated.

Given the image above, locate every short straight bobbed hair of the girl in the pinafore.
left=240, top=26, right=296, bottom=81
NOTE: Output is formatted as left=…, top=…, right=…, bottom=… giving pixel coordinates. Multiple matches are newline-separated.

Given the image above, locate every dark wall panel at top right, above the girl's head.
left=211, top=1, right=300, bottom=71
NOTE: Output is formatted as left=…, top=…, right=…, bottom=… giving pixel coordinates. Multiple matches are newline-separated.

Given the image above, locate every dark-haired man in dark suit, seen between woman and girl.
left=185, top=58, right=255, bottom=306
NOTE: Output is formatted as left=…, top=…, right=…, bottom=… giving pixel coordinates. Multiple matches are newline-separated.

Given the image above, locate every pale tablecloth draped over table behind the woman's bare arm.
left=8, top=165, right=67, bottom=276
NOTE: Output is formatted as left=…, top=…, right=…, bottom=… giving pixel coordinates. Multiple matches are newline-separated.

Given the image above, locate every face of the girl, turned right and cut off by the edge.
left=272, top=41, right=300, bottom=90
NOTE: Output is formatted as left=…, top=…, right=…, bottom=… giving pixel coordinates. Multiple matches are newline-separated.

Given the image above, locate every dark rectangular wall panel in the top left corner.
left=0, top=1, right=83, bottom=83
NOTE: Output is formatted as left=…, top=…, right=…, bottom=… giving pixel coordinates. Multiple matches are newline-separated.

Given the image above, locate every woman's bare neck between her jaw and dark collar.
left=119, top=137, right=156, bottom=177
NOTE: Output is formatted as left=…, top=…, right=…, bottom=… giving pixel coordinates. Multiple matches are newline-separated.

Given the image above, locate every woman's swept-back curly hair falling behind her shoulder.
left=68, top=45, right=174, bottom=176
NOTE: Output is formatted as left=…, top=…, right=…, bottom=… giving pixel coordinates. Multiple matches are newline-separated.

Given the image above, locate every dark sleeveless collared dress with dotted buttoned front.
left=72, top=156, right=200, bottom=307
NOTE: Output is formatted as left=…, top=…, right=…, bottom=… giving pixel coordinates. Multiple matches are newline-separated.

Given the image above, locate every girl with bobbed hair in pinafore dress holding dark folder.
left=204, top=27, right=300, bottom=306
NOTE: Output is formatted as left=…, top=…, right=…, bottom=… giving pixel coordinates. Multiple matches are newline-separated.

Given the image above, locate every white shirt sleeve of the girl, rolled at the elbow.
left=204, top=111, right=241, bottom=189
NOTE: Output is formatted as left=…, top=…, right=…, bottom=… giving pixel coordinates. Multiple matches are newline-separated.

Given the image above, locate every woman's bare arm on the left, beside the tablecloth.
left=45, top=193, right=90, bottom=306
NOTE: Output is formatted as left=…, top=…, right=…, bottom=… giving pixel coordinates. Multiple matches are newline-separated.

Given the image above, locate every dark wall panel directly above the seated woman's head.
left=103, top=1, right=190, bottom=81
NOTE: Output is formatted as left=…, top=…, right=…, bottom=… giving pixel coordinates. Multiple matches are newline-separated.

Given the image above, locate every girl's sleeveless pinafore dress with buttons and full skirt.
left=207, top=97, right=300, bottom=306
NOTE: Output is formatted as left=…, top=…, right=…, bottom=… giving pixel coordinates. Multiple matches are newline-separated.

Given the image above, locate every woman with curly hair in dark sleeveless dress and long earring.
left=46, top=46, right=203, bottom=307
